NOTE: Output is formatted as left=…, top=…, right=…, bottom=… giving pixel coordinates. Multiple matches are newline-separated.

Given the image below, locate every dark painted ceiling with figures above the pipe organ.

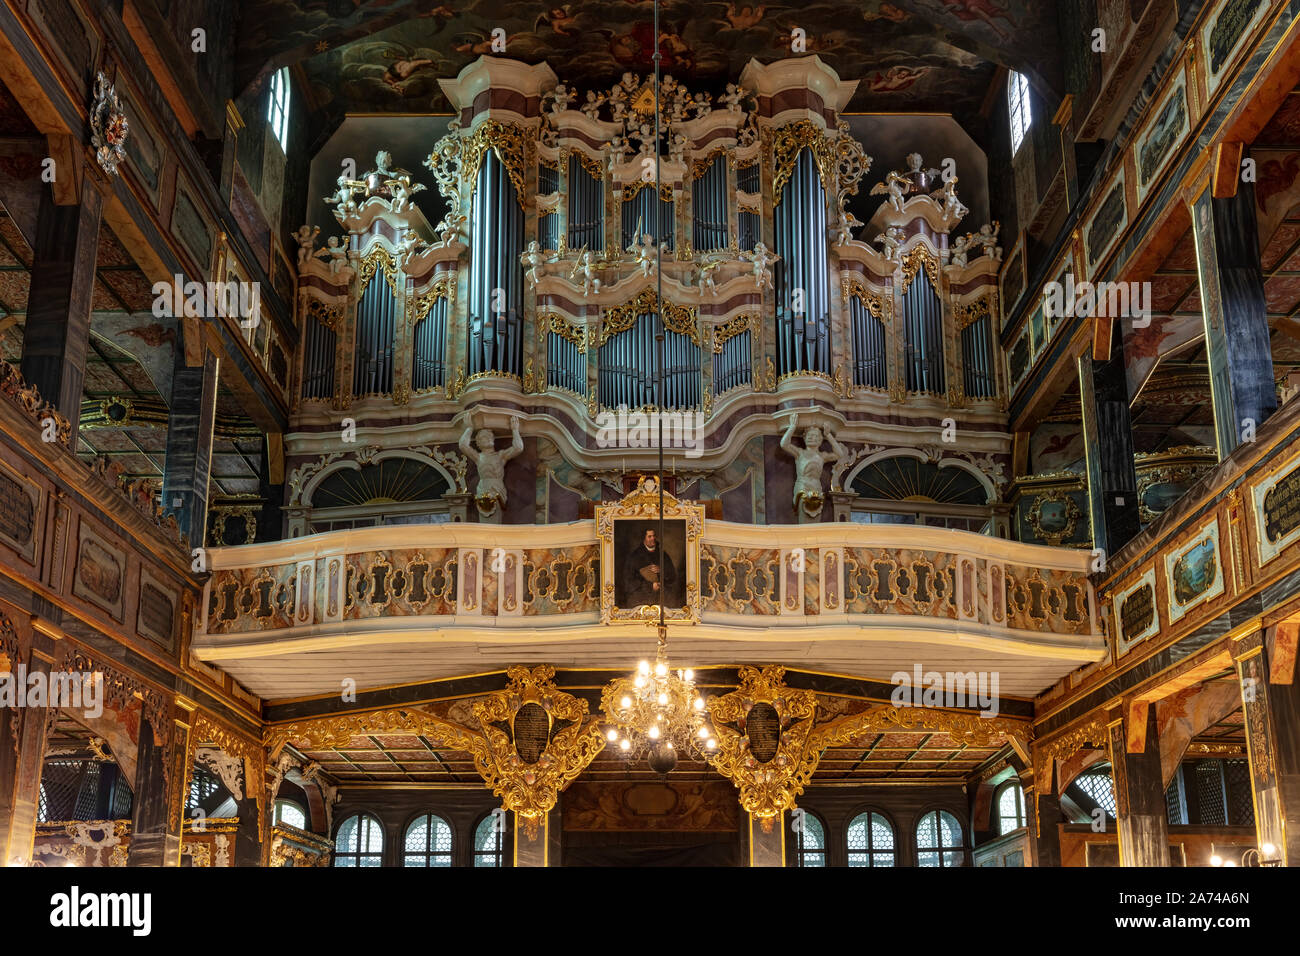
left=241, top=0, right=1060, bottom=127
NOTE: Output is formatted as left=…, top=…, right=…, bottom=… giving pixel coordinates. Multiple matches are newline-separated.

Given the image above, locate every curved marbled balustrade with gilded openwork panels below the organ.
left=199, top=520, right=1099, bottom=637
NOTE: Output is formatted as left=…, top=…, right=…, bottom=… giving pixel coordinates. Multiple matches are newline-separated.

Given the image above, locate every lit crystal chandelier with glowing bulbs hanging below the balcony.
left=601, top=623, right=718, bottom=774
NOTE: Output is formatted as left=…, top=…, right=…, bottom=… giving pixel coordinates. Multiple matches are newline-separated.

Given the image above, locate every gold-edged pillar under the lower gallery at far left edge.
left=0, top=631, right=57, bottom=866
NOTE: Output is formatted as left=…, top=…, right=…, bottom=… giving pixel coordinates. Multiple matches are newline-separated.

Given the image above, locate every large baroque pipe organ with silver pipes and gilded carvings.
left=287, top=51, right=1006, bottom=520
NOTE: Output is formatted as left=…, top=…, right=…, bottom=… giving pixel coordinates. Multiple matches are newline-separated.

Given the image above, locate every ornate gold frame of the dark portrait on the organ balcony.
left=595, top=475, right=705, bottom=624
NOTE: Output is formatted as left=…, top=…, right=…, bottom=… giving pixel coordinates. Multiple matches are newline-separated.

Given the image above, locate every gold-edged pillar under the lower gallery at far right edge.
left=1232, top=631, right=1300, bottom=866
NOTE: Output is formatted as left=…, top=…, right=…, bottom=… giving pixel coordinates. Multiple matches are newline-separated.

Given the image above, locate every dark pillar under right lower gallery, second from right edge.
left=1106, top=705, right=1169, bottom=866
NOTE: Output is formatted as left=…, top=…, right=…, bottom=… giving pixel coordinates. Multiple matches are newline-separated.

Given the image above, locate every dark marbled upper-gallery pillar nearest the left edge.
left=22, top=170, right=104, bottom=436
